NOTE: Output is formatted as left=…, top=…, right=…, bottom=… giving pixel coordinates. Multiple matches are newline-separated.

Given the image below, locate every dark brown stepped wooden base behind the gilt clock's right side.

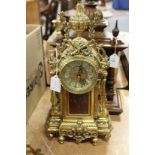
left=107, top=89, right=123, bottom=115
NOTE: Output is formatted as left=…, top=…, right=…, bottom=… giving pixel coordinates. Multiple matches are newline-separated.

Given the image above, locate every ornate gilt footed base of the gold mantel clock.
left=46, top=116, right=112, bottom=145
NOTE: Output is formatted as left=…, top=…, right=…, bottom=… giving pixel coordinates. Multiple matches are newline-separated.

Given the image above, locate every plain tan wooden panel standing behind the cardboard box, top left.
left=26, top=0, right=40, bottom=24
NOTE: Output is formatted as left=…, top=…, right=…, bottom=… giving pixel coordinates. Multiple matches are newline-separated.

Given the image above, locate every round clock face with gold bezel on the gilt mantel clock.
left=60, top=60, right=97, bottom=94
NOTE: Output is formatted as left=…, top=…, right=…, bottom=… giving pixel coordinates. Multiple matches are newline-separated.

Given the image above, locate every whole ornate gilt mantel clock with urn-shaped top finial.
left=46, top=3, right=112, bottom=145
